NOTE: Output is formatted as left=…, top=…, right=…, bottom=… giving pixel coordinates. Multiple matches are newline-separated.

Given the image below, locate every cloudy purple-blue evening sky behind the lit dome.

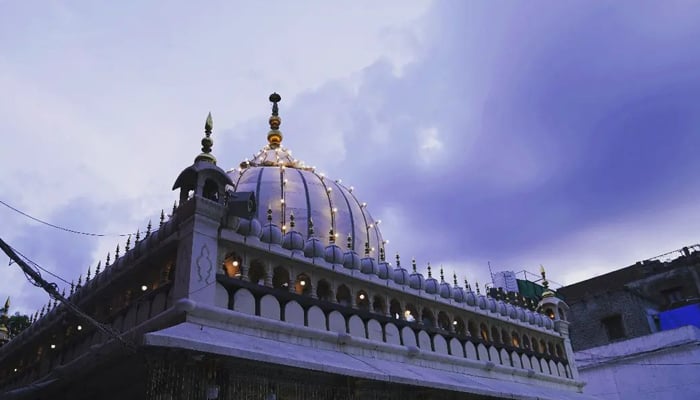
left=0, top=0, right=700, bottom=312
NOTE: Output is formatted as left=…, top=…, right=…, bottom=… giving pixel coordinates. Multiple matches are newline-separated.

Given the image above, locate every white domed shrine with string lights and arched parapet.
left=0, top=93, right=591, bottom=400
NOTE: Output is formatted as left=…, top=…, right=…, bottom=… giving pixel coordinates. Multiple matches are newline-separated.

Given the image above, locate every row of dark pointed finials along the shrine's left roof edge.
left=29, top=206, right=177, bottom=323
